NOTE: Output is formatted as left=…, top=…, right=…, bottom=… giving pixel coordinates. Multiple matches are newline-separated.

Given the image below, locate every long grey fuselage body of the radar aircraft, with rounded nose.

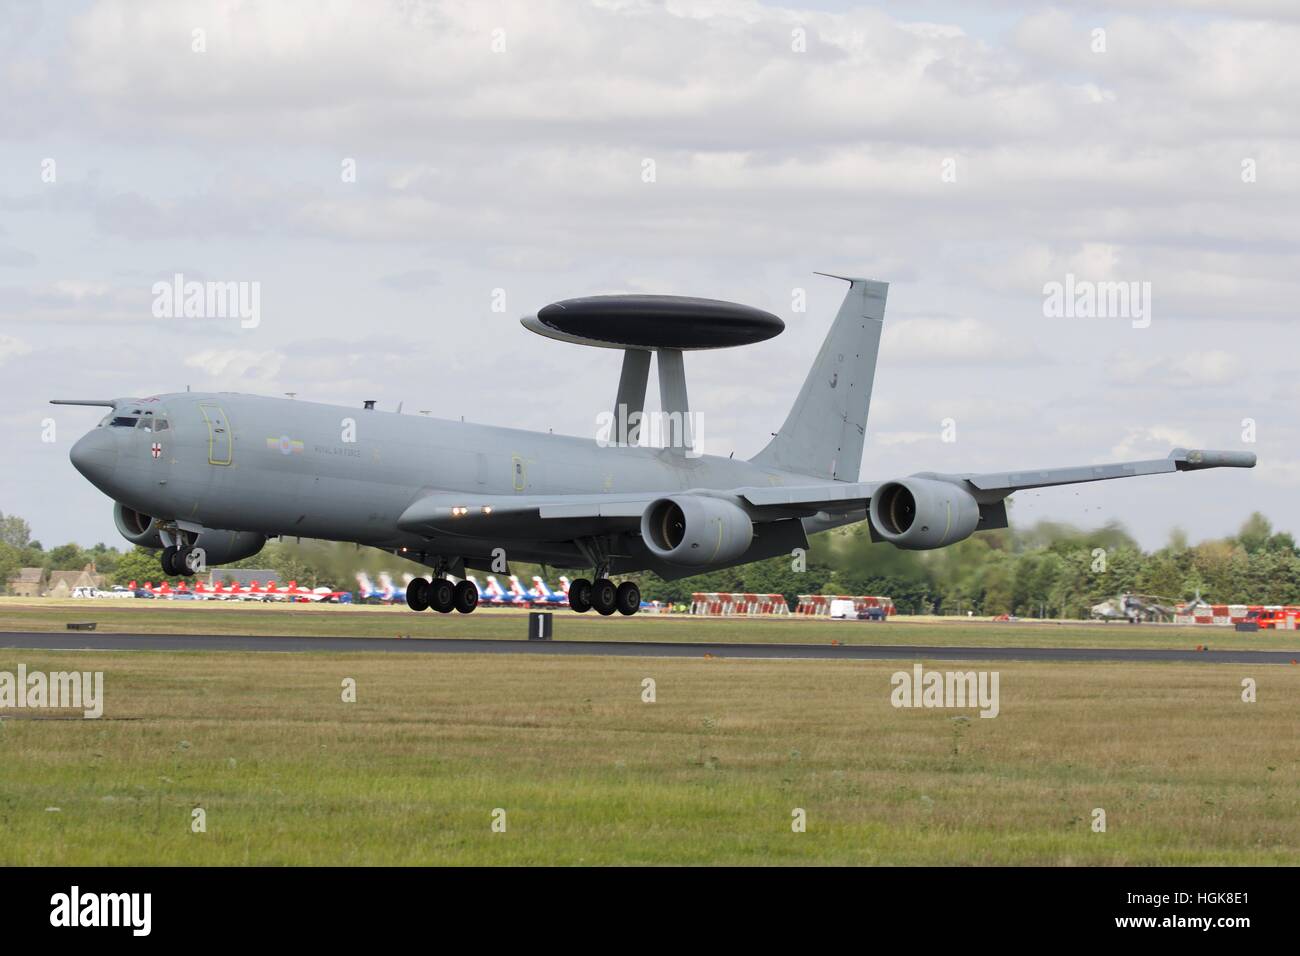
left=72, top=392, right=855, bottom=564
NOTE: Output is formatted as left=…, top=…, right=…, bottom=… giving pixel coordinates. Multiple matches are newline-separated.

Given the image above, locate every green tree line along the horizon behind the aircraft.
left=0, top=512, right=1300, bottom=618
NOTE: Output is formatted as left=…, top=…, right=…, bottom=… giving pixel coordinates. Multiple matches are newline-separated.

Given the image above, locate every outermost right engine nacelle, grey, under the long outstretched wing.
left=870, top=477, right=979, bottom=551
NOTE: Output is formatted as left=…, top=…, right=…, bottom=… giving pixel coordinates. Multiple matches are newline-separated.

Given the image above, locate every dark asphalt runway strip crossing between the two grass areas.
left=0, top=631, right=1300, bottom=665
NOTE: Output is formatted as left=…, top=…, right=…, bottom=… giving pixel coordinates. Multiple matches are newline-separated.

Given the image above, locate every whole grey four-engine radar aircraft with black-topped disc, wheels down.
left=57, top=277, right=1255, bottom=614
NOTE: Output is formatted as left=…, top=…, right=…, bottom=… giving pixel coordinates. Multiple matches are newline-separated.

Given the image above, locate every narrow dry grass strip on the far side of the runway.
left=0, top=598, right=1300, bottom=656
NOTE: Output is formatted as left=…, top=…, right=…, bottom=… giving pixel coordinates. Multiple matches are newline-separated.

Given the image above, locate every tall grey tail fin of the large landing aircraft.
left=750, top=273, right=889, bottom=481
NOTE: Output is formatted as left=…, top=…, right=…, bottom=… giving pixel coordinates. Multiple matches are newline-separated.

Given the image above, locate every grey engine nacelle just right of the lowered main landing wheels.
left=641, top=494, right=754, bottom=567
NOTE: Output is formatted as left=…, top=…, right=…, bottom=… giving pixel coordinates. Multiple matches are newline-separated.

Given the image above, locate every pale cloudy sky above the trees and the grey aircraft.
left=0, top=0, right=1300, bottom=546
